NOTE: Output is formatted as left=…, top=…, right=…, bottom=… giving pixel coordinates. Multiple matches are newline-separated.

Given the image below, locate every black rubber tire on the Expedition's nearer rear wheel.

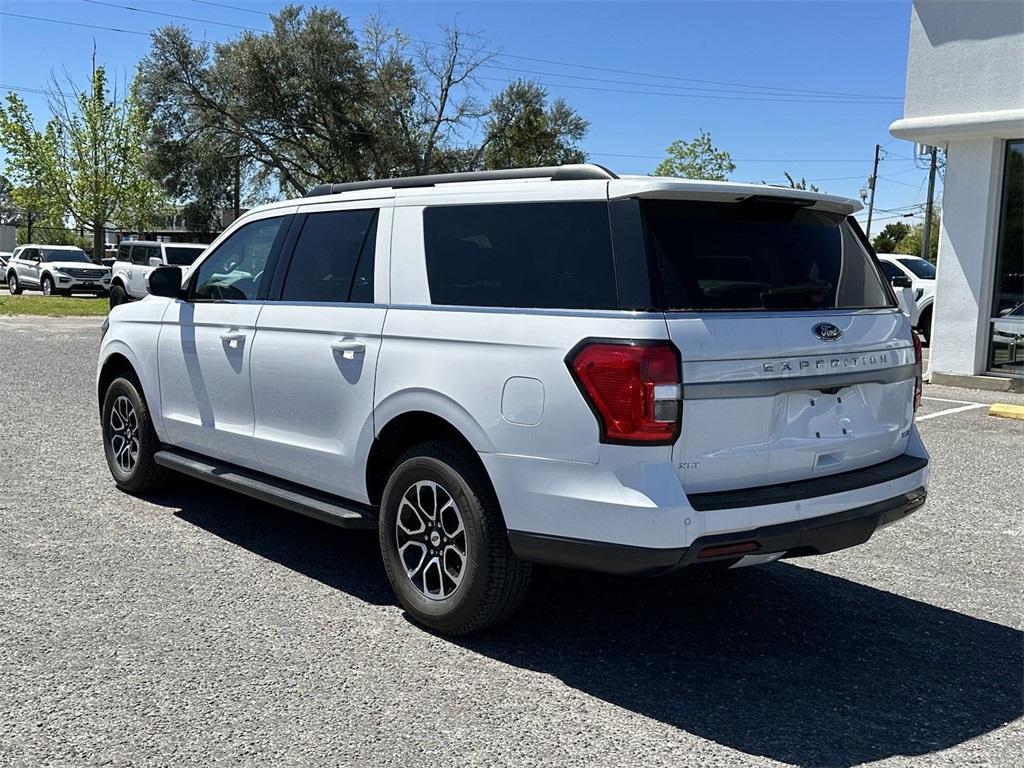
left=378, top=441, right=531, bottom=635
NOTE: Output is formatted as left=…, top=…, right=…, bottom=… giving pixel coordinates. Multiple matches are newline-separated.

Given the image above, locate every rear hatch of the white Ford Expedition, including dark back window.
left=640, top=197, right=916, bottom=494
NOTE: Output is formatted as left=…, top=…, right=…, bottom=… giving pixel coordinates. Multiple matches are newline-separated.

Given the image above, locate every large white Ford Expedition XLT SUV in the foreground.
left=97, top=166, right=928, bottom=634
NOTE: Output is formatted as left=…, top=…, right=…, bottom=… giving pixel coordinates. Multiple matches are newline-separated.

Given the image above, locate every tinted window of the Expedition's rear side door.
left=281, top=210, right=377, bottom=304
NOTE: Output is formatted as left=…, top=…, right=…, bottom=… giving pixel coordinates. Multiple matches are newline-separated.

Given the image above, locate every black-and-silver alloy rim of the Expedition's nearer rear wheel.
left=394, top=480, right=469, bottom=600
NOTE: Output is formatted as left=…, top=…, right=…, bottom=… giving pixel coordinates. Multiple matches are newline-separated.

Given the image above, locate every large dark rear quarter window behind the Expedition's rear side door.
left=423, top=203, right=618, bottom=309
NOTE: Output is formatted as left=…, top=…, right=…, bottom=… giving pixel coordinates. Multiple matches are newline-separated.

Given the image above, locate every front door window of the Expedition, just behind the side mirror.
left=191, top=216, right=284, bottom=301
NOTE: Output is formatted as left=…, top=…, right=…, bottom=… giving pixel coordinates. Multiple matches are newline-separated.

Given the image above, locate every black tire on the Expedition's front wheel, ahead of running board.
left=100, top=377, right=167, bottom=495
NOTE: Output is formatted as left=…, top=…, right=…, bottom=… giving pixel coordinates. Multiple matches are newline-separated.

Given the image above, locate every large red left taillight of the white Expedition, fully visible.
left=565, top=340, right=683, bottom=445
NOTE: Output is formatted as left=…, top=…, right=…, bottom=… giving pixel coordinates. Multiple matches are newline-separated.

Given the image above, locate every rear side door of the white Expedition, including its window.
left=252, top=202, right=392, bottom=501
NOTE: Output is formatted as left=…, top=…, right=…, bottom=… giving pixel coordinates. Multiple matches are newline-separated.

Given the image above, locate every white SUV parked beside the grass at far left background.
left=6, top=244, right=111, bottom=296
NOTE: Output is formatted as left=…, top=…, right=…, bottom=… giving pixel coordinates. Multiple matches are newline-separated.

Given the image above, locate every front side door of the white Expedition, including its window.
left=158, top=215, right=287, bottom=468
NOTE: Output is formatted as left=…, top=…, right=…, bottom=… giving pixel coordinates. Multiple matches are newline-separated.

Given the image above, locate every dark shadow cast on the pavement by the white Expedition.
left=163, top=480, right=1024, bottom=768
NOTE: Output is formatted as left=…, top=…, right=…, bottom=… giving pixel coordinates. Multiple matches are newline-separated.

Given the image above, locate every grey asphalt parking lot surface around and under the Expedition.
left=0, top=318, right=1024, bottom=768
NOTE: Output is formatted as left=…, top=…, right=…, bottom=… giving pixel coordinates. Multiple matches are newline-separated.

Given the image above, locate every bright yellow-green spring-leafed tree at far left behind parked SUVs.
left=0, top=56, right=163, bottom=258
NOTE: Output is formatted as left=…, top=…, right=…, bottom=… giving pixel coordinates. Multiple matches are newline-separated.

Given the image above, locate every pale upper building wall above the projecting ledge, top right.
left=903, top=0, right=1024, bottom=118
